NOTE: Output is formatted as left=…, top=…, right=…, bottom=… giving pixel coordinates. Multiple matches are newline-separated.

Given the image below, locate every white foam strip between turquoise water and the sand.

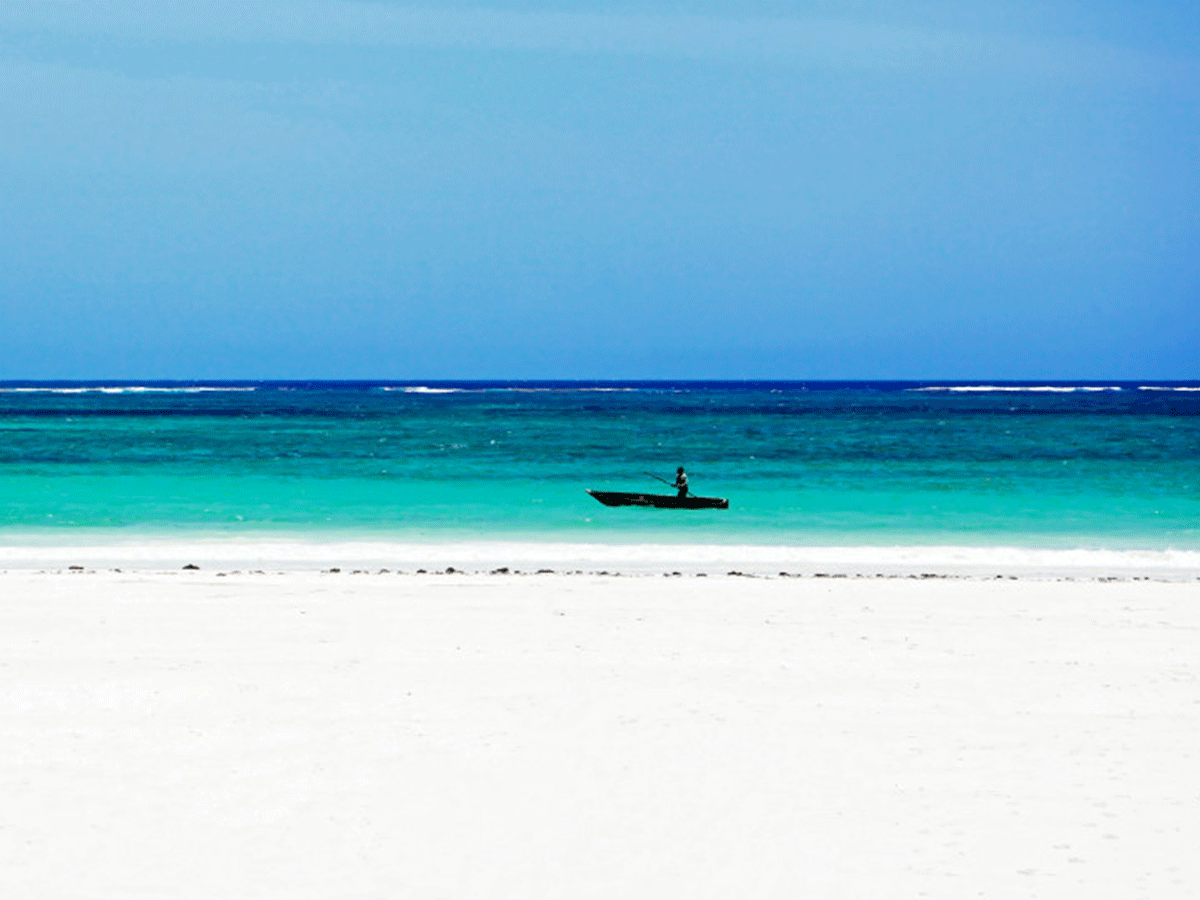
left=0, top=539, right=1200, bottom=580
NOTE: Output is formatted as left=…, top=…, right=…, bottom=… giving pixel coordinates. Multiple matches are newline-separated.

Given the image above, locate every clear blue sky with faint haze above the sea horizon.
left=0, top=0, right=1200, bottom=379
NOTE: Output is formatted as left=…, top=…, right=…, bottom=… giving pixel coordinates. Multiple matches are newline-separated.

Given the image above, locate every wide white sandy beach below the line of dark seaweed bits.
left=0, top=559, right=1200, bottom=900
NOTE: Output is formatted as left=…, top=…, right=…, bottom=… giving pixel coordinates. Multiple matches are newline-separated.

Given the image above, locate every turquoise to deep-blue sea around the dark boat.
left=0, top=383, right=1200, bottom=548
